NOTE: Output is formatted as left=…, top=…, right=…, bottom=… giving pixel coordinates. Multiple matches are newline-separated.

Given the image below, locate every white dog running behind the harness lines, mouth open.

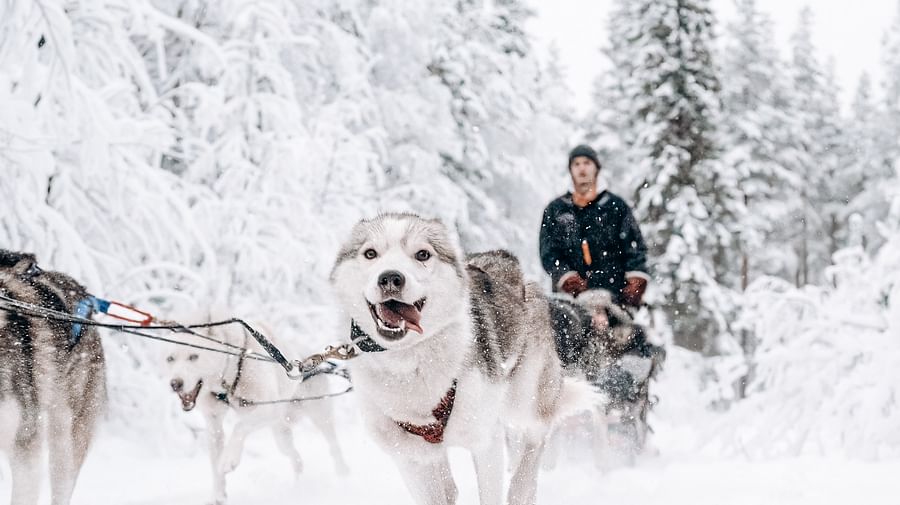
left=165, top=319, right=348, bottom=505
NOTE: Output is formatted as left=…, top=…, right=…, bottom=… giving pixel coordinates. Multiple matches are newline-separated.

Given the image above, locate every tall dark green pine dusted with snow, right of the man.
left=598, top=0, right=743, bottom=353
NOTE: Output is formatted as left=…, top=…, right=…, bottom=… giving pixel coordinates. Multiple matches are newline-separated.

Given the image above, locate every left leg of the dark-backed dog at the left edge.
left=10, top=414, right=43, bottom=505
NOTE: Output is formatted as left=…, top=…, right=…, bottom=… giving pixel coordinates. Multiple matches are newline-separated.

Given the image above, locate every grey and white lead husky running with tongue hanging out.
left=331, top=214, right=586, bottom=505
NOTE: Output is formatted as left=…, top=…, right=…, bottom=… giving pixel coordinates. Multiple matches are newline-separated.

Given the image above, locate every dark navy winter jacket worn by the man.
left=540, top=191, right=649, bottom=302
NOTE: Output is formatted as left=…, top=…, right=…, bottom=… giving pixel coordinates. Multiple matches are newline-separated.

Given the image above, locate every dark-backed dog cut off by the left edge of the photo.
left=0, top=249, right=106, bottom=505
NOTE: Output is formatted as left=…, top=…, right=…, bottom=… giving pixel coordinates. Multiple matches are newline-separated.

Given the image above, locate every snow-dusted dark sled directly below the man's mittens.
left=550, top=291, right=665, bottom=464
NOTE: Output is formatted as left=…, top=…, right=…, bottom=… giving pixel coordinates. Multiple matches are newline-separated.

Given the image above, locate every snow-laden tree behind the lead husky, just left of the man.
left=414, top=0, right=574, bottom=271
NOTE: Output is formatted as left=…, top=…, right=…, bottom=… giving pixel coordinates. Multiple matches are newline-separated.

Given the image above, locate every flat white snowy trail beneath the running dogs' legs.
left=0, top=418, right=900, bottom=505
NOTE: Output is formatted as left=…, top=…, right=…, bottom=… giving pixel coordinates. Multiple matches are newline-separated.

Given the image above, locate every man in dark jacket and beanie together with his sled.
left=540, top=145, right=665, bottom=460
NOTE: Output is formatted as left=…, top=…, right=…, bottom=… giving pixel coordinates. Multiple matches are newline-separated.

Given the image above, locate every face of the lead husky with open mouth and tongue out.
left=331, top=214, right=468, bottom=348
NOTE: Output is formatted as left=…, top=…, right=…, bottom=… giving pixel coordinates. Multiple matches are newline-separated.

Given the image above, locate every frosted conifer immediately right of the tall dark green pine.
left=721, top=0, right=801, bottom=288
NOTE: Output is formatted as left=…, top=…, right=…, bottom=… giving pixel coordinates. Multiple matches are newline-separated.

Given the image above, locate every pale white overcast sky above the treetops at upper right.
left=530, top=0, right=900, bottom=110
